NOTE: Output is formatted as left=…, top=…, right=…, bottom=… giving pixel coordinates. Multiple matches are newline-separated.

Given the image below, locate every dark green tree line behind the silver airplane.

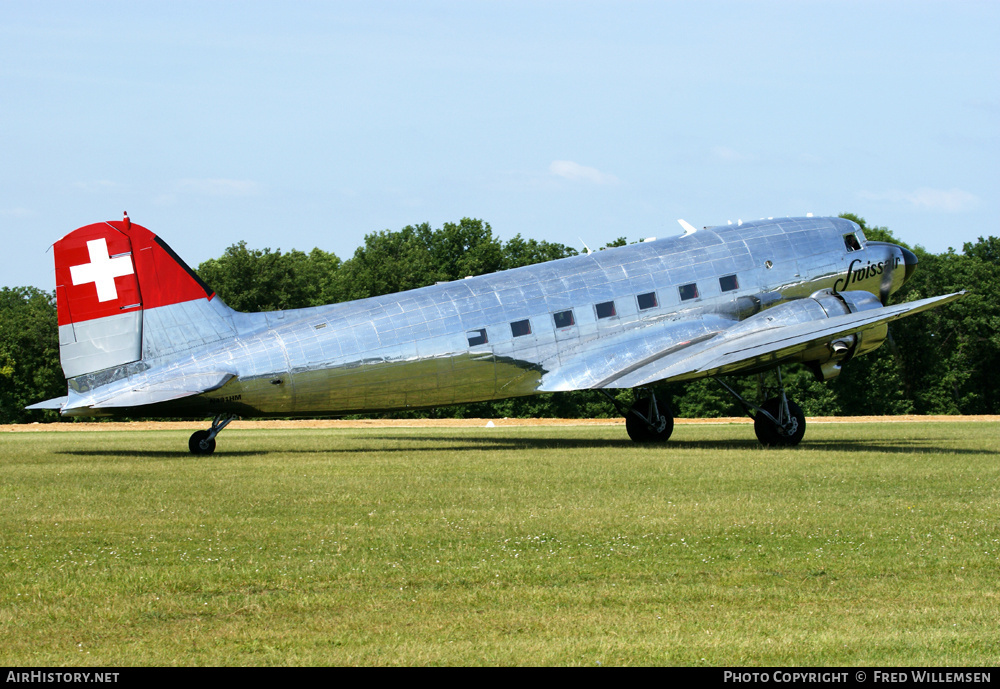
left=0, top=214, right=1000, bottom=423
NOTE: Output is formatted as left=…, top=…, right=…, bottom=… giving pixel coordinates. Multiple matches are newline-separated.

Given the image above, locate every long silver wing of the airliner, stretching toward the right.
left=541, top=292, right=965, bottom=390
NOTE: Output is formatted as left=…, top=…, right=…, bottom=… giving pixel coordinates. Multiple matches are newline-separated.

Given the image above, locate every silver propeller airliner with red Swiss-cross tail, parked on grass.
left=28, top=214, right=964, bottom=454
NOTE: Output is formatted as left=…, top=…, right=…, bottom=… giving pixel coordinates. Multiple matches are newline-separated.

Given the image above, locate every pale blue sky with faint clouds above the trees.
left=0, top=0, right=1000, bottom=289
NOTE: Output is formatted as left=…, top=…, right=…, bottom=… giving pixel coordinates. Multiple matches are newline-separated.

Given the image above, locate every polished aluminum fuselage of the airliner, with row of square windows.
left=62, top=218, right=904, bottom=416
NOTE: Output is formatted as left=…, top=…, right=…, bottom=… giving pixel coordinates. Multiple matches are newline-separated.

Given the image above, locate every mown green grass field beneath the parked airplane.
left=0, top=422, right=1000, bottom=666
